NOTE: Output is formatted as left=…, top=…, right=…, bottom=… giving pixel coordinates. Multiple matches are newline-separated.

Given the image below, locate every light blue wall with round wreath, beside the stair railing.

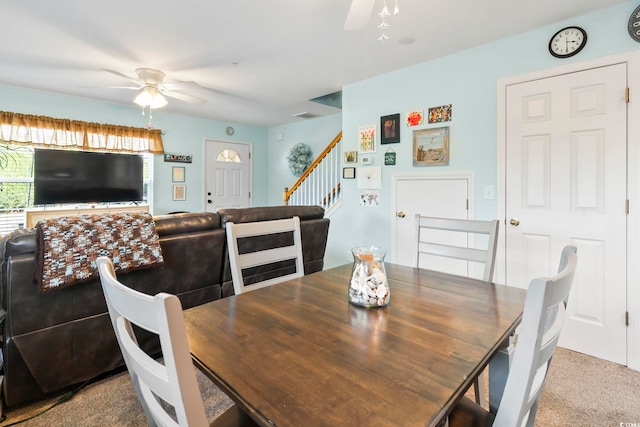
left=268, top=113, right=342, bottom=205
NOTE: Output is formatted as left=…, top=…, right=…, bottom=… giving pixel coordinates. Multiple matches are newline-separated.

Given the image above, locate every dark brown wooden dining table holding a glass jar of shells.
left=184, top=263, right=526, bottom=427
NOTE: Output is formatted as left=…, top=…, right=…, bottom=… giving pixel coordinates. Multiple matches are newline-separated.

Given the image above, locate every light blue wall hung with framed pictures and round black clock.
left=269, top=2, right=640, bottom=267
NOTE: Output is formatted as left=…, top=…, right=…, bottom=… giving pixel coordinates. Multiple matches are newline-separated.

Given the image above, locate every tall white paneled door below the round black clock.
left=505, top=64, right=627, bottom=364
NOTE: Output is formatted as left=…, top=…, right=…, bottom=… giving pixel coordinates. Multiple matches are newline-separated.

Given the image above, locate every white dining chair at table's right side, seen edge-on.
left=449, top=246, right=578, bottom=427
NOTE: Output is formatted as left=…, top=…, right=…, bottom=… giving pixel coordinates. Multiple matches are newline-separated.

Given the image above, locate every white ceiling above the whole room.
left=0, top=0, right=625, bottom=126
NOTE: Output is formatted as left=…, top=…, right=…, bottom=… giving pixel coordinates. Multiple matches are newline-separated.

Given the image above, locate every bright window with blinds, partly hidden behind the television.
left=0, top=142, right=153, bottom=235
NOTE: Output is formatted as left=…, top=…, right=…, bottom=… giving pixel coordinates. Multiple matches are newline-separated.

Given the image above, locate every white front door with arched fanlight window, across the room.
left=205, top=140, right=251, bottom=212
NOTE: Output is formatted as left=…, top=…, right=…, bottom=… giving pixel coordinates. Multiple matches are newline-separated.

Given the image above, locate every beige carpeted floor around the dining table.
left=0, top=348, right=640, bottom=427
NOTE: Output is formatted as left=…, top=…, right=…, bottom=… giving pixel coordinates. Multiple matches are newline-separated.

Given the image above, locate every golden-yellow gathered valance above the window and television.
left=0, top=111, right=164, bottom=154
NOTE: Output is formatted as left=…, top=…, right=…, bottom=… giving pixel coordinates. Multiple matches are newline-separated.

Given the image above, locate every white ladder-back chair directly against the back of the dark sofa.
left=226, top=216, right=304, bottom=295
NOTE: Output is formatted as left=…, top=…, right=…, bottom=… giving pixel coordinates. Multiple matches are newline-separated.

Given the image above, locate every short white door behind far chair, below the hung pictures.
left=392, top=175, right=470, bottom=275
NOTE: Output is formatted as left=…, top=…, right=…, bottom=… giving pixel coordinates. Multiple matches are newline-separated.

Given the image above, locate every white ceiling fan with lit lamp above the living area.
left=103, top=68, right=207, bottom=108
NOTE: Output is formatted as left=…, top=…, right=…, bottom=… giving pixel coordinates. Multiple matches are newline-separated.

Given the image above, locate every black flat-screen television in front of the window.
left=33, top=149, right=143, bottom=205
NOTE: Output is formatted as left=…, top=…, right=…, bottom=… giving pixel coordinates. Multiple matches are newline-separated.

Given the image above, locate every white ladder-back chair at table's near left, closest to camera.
left=96, top=256, right=255, bottom=427
